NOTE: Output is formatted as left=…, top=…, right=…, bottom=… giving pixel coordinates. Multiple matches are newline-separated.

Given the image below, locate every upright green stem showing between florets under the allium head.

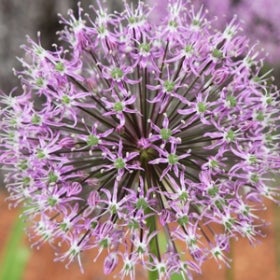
left=146, top=212, right=160, bottom=280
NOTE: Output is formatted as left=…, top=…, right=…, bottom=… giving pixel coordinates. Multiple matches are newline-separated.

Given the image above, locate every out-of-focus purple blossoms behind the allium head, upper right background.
left=152, top=0, right=280, bottom=65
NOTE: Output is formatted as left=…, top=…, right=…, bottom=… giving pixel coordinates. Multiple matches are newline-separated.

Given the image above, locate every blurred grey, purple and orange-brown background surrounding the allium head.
left=0, top=0, right=280, bottom=280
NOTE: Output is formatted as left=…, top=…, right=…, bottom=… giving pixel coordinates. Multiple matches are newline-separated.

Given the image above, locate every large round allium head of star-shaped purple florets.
left=0, top=0, right=280, bottom=279
